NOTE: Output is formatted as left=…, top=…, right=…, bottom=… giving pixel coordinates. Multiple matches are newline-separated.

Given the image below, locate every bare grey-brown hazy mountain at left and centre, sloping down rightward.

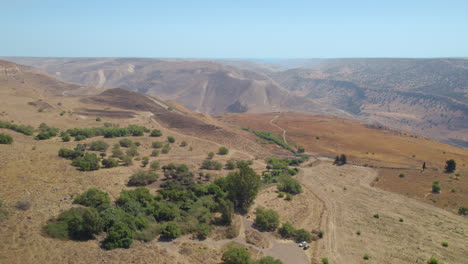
left=4, top=58, right=339, bottom=114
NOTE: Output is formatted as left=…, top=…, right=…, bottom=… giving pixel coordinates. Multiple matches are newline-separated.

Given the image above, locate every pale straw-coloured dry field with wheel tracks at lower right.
left=298, top=161, right=468, bottom=264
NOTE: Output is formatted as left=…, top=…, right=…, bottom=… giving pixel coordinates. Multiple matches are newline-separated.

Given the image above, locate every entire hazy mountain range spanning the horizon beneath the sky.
left=6, top=58, right=468, bottom=147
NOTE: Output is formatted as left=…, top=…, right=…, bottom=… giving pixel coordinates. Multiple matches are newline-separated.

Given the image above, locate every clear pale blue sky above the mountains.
left=0, top=0, right=468, bottom=58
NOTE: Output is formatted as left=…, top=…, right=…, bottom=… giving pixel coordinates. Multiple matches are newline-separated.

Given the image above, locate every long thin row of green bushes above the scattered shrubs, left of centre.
left=67, top=125, right=150, bottom=140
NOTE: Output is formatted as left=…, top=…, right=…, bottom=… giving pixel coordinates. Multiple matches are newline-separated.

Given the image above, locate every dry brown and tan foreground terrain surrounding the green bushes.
left=0, top=59, right=468, bottom=264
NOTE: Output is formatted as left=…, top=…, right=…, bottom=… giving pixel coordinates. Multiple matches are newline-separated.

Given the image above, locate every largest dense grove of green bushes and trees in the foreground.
left=44, top=164, right=261, bottom=249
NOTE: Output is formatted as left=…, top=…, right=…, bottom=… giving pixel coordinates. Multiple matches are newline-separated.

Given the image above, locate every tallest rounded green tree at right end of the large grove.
left=226, top=166, right=261, bottom=211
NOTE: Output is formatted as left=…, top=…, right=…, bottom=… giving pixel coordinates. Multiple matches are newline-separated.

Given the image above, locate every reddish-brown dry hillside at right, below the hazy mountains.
left=217, top=113, right=468, bottom=211
